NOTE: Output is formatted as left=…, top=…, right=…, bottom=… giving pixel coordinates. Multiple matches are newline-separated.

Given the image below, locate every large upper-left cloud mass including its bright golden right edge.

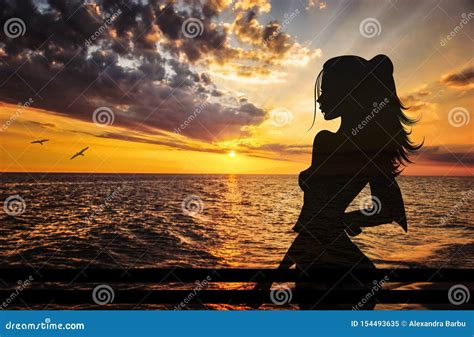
left=0, top=0, right=320, bottom=146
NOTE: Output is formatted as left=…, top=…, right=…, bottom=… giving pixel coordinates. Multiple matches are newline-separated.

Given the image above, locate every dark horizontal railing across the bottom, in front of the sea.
left=0, top=268, right=474, bottom=308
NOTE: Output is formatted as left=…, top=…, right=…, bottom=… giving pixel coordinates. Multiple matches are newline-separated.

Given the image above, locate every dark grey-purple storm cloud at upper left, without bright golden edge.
left=0, top=0, right=265, bottom=141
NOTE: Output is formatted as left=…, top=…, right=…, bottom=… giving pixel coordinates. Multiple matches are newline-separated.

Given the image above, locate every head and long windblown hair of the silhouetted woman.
left=311, top=55, right=423, bottom=175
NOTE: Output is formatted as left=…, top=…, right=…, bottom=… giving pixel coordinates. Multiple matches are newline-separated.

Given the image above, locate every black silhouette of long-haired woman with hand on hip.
left=256, top=55, right=421, bottom=309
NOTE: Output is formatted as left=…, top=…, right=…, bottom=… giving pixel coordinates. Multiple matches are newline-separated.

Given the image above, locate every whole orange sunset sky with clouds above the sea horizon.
left=0, top=0, right=474, bottom=176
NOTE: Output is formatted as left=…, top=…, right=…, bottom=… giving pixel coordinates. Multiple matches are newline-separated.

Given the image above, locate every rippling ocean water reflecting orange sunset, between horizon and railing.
left=0, top=173, right=474, bottom=308
